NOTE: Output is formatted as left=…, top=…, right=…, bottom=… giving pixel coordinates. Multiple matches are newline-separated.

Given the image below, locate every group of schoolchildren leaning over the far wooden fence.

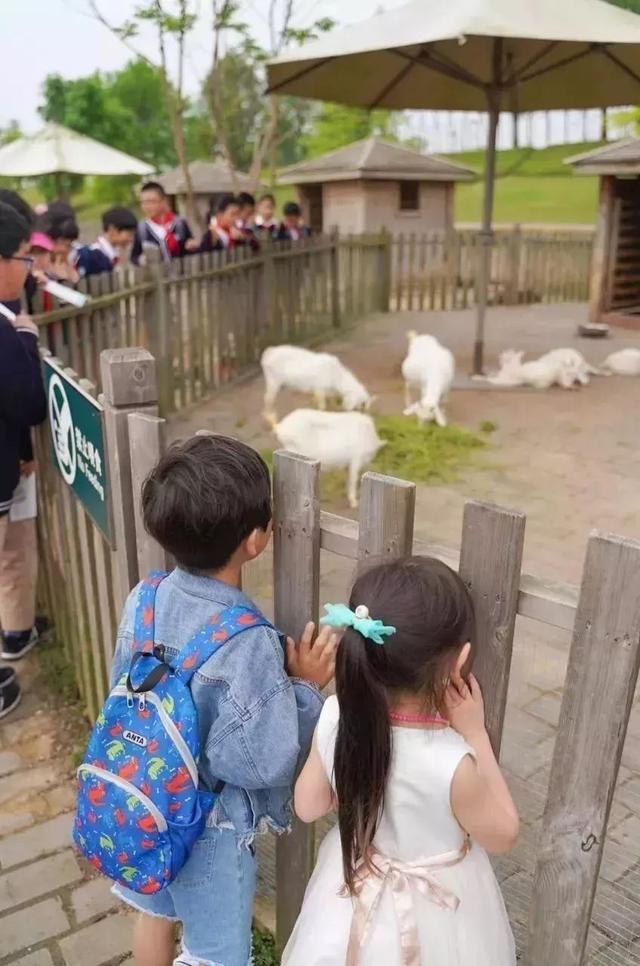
left=20, top=181, right=309, bottom=298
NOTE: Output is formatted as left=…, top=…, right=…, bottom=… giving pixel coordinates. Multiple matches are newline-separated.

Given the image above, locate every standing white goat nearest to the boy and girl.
left=273, top=409, right=384, bottom=507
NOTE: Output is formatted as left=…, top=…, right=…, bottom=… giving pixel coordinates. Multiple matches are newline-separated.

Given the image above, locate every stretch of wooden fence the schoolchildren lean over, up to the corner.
left=36, top=235, right=389, bottom=414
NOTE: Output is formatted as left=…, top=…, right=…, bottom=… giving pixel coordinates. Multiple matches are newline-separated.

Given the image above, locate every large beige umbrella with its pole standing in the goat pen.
left=268, top=0, right=640, bottom=373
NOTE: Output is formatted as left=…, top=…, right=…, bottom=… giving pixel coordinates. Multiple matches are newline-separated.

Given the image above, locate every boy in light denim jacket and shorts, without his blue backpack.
left=111, top=435, right=335, bottom=966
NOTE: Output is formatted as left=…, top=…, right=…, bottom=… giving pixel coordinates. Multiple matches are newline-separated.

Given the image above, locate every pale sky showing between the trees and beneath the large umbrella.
left=0, top=0, right=622, bottom=152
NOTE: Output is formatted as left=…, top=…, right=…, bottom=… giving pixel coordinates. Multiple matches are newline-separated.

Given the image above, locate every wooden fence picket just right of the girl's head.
left=460, top=502, right=526, bottom=755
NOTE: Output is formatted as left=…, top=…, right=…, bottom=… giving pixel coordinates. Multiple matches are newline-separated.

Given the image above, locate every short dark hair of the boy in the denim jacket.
left=142, top=435, right=271, bottom=572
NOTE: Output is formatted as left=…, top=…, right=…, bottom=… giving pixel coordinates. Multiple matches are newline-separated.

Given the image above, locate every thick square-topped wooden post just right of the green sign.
left=100, top=349, right=158, bottom=610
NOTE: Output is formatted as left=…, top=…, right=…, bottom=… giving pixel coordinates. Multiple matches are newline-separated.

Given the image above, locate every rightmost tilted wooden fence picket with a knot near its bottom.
left=526, top=533, right=640, bottom=966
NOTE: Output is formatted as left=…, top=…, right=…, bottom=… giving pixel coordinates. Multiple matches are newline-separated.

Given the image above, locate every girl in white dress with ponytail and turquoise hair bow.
left=282, top=557, right=518, bottom=966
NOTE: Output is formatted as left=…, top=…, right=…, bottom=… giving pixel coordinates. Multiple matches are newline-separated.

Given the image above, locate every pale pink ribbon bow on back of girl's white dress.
left=346, top=838, right=471, bottom=966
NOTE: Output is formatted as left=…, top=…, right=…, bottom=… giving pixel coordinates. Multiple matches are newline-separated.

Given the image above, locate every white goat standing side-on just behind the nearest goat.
left=260, top=345, right=372, bottom=418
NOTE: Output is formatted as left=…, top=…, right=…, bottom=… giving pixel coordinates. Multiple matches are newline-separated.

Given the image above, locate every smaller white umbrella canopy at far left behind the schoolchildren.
left=0, top=124, right=154, bottom=178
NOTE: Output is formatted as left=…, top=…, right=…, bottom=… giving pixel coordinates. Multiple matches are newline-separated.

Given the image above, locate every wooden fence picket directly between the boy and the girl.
left=273, top=453, right=320, bottom=950
